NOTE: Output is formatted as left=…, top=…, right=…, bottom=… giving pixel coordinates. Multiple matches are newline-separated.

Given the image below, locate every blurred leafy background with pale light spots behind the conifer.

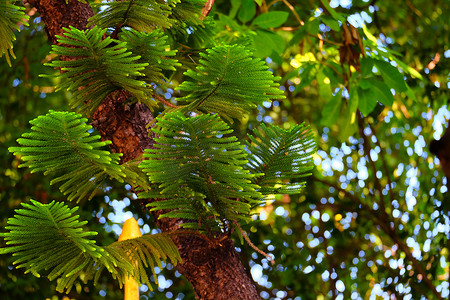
left=0, top=0, right=450, bottom=300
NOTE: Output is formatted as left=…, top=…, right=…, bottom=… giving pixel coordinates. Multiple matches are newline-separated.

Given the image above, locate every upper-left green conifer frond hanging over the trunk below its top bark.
left=46, top=26, right=151, bottom=115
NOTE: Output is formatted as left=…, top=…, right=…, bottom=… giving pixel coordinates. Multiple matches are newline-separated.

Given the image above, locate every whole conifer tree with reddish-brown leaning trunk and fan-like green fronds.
left=0, top=0, right=315, bottom=299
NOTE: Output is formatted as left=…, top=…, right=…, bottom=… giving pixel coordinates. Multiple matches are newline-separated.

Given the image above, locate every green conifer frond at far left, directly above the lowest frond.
left=9, top=111, right=127, bottom=200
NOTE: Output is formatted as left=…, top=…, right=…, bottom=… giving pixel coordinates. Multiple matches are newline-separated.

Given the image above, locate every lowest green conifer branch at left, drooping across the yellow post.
left=0, top=200, right=181, bottom=292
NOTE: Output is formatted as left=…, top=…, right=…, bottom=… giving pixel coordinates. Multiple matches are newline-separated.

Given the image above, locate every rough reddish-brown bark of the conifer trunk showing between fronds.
left=28, top=0, right=260, bottom=300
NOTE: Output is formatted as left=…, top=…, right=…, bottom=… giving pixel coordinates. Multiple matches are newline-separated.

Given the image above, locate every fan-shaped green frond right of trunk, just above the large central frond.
left=178, top=45, right=284, bottom=118
